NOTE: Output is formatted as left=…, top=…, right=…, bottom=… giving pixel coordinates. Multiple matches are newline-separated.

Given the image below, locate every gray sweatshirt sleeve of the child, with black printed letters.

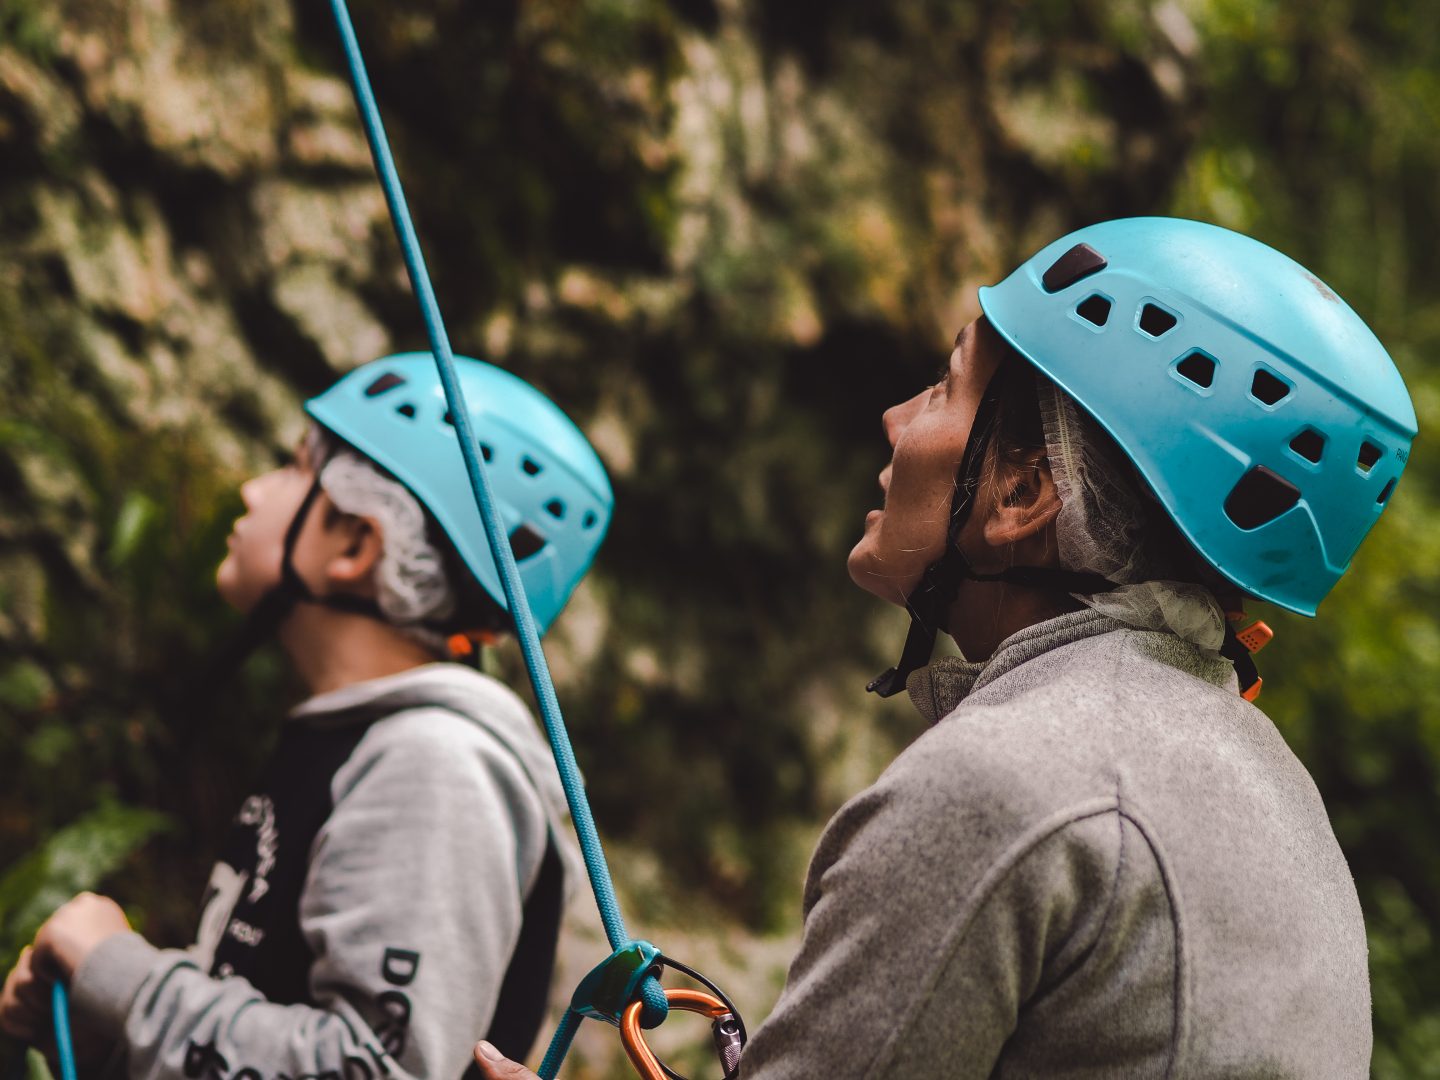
left=75, top=710, right=547, bottom=1080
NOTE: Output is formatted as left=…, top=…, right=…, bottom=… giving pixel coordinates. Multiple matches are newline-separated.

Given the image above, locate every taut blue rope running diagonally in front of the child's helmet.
left=331, top=0, right=668, bottom=1080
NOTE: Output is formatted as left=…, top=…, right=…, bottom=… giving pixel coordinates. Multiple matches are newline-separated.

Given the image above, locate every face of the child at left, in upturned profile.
left=215, top=444, right=324, bottom=612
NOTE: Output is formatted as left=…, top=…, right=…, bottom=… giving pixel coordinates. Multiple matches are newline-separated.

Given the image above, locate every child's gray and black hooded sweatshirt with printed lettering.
left=72, top=664, right=569, bottom=1080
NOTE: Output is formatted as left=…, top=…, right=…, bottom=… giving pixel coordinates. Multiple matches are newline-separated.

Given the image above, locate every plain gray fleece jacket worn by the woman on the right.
left=742, top=611, right=1371, bottom=1080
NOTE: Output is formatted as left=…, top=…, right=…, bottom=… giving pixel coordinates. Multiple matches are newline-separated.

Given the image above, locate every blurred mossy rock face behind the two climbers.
left=0, top=0, right=1197, bottom=1077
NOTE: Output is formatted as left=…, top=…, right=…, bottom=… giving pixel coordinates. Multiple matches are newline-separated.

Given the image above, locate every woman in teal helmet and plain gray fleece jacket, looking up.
left=477, top=219, right=1416, bottom=1080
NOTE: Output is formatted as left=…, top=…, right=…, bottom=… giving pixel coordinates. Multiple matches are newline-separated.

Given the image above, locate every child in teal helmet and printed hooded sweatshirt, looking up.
left=0, top=354, right=612, bottom=1079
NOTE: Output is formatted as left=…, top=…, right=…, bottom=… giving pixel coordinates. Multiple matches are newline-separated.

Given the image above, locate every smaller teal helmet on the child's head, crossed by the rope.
left=305, top=353, right=615, bottom=634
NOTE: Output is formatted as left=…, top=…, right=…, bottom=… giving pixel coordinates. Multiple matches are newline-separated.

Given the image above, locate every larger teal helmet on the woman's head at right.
left=979, top=217, right=1417, bottom=615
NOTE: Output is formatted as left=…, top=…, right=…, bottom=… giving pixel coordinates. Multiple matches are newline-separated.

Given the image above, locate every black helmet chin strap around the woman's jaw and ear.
left=865, top=370, right=1116, bottom=697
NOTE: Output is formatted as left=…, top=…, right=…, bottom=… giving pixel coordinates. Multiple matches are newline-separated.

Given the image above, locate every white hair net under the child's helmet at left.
left=310, top=426, right=455, bottom=651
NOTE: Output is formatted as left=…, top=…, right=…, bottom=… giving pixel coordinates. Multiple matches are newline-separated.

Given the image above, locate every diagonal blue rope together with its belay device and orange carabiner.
left=331, top=0, right=744, bottom=1080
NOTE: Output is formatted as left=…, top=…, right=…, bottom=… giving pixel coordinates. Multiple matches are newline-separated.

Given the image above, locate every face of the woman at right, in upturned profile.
left=848, top=318, right=1004, bottom=606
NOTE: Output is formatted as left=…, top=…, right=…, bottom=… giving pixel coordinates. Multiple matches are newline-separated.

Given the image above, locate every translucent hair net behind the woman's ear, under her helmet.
left=1038, top=391, right=1225, bottom=651
